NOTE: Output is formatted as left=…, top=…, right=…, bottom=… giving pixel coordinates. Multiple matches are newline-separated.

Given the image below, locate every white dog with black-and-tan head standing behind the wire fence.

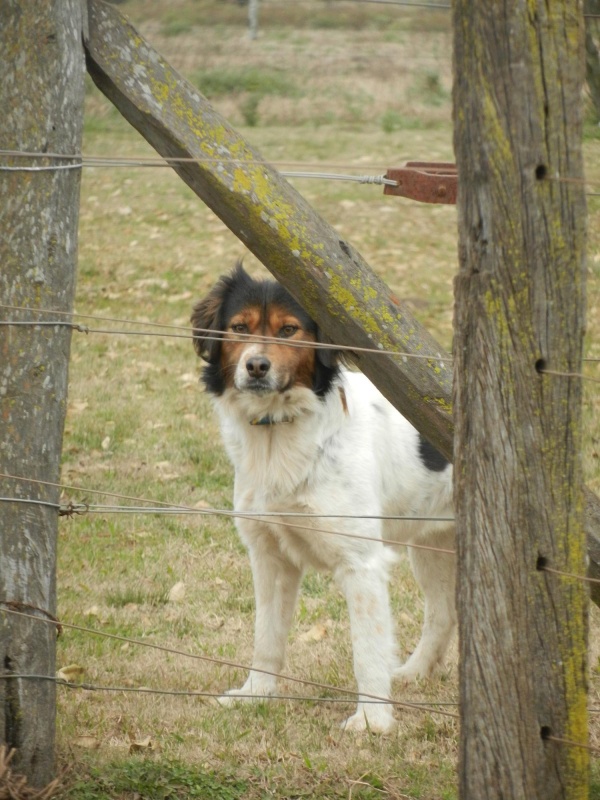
left=191, top=262, right=456, bottom=732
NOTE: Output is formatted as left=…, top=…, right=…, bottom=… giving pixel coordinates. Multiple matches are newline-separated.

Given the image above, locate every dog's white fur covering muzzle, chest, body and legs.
left=215, top=356, right=456, bottom=732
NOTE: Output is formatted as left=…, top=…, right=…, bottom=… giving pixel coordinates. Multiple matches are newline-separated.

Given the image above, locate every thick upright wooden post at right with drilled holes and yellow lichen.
left=453, top=0, right=588, bottom=800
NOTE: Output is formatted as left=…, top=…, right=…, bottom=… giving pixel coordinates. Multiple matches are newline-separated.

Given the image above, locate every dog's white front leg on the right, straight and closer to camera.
left=336, top=564, right=396, bottom=733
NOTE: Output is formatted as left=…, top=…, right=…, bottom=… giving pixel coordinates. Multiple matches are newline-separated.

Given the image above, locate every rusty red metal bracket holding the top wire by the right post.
left=383, top=161, right=458, bottom=204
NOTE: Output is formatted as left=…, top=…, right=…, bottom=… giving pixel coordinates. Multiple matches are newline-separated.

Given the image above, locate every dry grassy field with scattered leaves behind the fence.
left=58, top=0, right=600, bottom=800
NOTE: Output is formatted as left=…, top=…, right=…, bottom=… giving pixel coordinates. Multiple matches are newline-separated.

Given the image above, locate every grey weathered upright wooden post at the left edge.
left=0, top=0, right=85, bottom=786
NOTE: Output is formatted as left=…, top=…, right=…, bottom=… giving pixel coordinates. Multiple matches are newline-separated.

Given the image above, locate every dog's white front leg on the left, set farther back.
left=220, top=534, right=302, bottom=705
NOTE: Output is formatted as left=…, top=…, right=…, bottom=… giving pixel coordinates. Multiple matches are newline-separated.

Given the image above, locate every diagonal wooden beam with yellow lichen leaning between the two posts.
left=86, top=0, right=600, bottom=605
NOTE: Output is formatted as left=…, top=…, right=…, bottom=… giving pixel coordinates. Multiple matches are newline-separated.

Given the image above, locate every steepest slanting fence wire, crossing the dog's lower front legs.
left=0, top=600, right=458, bottom=719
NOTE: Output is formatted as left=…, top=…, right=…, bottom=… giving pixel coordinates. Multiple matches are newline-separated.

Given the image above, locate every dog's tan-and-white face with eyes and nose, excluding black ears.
left=221, top=305, right=315, bottom=393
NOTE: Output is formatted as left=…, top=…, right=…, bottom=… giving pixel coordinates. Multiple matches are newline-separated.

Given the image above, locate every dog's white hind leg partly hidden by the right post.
left=395, top=531, right=456, bottom=681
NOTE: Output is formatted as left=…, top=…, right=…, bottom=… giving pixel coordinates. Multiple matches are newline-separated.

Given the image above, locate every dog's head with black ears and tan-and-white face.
left=191, top=262, right=338, bottom=397
